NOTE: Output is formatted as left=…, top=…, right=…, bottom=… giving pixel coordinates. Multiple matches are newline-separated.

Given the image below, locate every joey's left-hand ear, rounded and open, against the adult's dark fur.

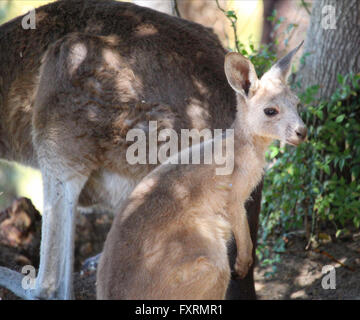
left=225, top=52, right=258, bottom=99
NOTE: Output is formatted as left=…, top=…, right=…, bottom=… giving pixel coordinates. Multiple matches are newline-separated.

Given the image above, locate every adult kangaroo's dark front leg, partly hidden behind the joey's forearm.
left=226, top=181, right=263, bottom=300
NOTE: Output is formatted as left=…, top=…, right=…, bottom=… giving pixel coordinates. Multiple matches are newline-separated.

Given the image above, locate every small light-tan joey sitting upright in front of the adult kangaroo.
left=97, top=49, right=305, bottom=299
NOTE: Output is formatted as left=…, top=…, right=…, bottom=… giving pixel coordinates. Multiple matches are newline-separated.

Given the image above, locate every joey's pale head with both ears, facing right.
left=225, top=43, right=307, bottom=145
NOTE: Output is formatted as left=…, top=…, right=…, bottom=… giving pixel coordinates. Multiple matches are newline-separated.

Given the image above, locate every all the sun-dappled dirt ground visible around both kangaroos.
left=0, top=200, right=360, bottom=300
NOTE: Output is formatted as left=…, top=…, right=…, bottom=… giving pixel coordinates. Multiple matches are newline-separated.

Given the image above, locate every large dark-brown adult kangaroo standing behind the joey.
left=0, top=0, right=262, bottom=299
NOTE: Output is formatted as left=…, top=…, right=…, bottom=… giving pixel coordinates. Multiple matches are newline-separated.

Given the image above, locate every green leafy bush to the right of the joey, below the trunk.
left=260, top=73, right=360, bottom=266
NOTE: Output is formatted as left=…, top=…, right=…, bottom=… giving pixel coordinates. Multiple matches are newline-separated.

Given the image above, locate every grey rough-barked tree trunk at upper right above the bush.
left=299, top=0, right=360, bottom=98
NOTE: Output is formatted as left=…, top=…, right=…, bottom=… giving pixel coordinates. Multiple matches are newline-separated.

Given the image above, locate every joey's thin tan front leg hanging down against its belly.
left=228, top=202, right=253, bottom=278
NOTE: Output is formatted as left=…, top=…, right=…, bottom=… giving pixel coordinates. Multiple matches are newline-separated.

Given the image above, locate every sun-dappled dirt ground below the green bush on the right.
left=255, top=233, right=360, bottom=300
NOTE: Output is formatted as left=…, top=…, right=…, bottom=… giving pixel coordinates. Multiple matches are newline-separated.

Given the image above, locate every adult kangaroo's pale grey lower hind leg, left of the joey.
left=34, top=167, right=87, bottom=299
